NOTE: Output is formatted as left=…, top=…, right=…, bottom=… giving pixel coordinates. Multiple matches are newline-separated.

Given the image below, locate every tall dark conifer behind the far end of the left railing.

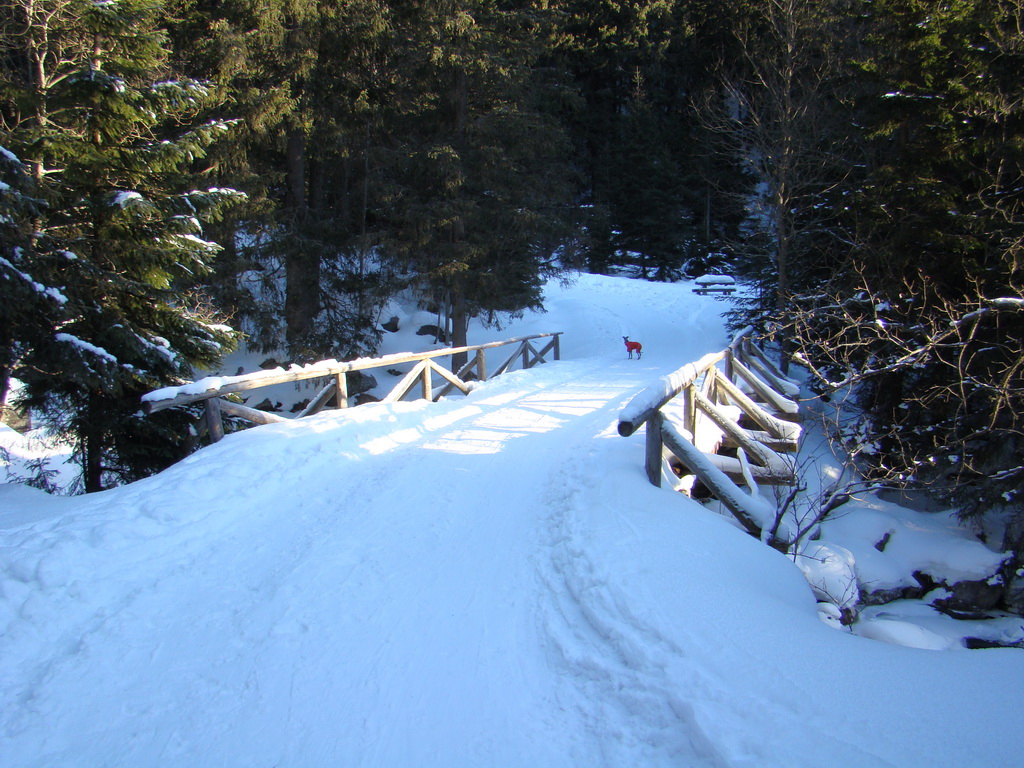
left=390, top=0, right=572, bottom=364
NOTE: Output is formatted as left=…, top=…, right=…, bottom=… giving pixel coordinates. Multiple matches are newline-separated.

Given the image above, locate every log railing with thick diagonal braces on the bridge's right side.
left=618, top=328, right=801, bottom=548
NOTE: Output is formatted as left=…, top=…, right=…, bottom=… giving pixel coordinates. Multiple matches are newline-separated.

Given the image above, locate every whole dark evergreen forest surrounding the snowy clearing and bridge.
left=0, top=0, right=1024, bottom=551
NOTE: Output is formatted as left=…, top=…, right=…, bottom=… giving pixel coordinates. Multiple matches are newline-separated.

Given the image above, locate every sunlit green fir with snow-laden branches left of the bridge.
left=3, top=0, right=241, bottom=492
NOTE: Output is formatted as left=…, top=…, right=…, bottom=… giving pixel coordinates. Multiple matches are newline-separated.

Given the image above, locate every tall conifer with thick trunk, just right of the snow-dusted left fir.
left=165, top=0, right=409, bottom=359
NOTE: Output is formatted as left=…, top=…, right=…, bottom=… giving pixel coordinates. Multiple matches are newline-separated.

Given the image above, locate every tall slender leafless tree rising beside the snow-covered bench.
left=702, top=0, right=856, bottom=352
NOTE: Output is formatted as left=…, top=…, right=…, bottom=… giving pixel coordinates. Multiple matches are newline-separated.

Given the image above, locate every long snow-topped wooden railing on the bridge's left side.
left=142, top=331, right=561, bottom=442
